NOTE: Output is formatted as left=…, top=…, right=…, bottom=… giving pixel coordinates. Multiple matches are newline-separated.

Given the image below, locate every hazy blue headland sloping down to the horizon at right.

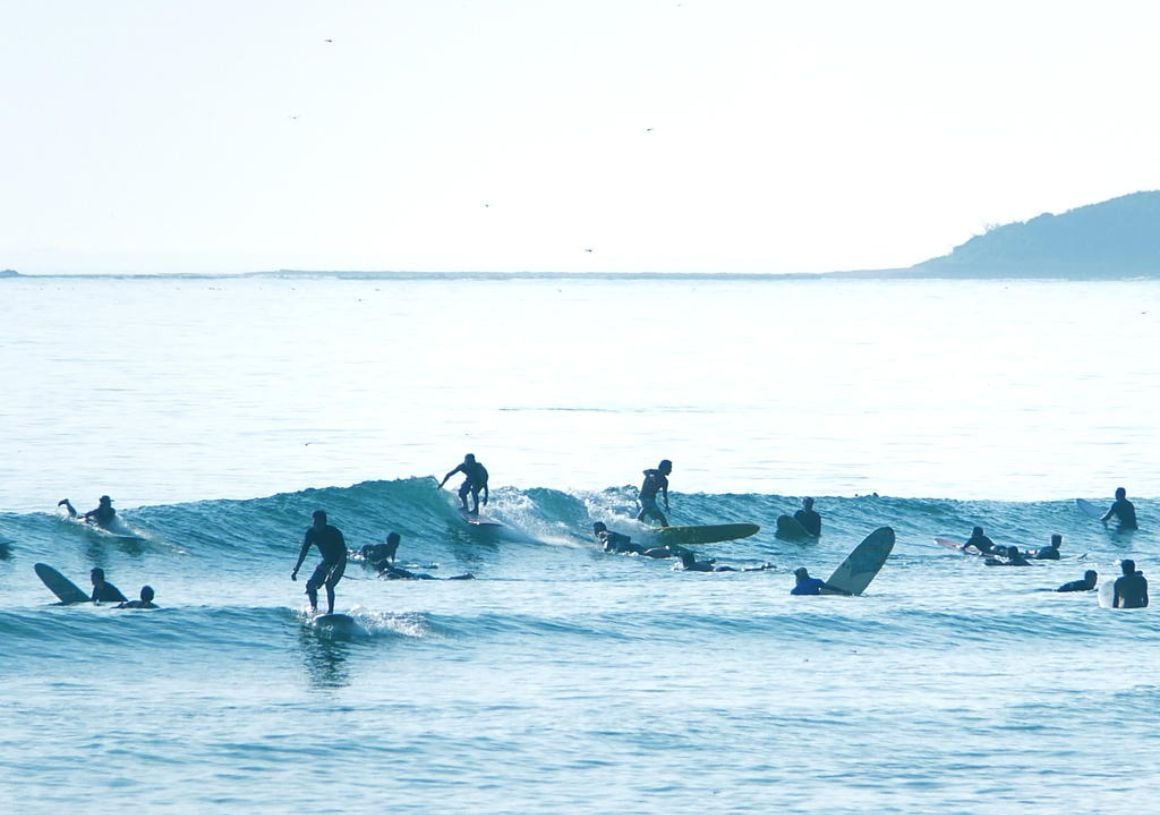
left=833, top=190, right=1160, bottom=281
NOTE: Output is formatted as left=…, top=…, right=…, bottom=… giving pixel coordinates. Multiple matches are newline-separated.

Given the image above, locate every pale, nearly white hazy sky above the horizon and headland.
left=0, top=0, right=1160, bottom=274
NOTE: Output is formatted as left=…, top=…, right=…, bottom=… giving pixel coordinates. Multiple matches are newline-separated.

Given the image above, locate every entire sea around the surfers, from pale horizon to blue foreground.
left=0, top=275, right=1160, bottom=814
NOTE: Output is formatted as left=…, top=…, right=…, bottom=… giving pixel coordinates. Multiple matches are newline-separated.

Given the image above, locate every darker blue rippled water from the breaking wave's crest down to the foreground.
left=0, top=479, right=1160, bottom=815
